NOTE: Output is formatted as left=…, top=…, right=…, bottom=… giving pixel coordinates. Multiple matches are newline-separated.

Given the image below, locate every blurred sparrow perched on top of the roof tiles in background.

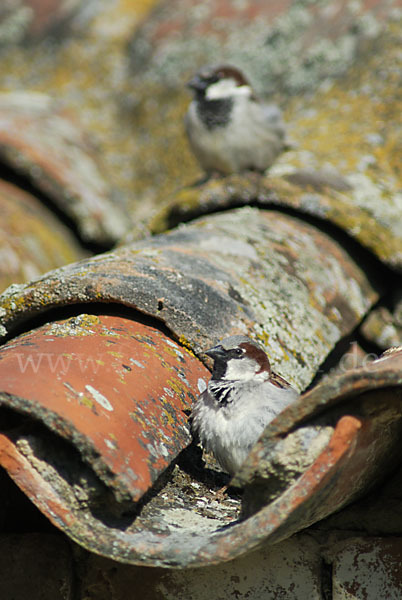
left=185, top=65, right=291, bottom=176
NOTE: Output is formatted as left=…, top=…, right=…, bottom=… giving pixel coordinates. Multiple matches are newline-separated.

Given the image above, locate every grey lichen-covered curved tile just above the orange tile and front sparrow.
left=0, top=208, right=379, bottom=388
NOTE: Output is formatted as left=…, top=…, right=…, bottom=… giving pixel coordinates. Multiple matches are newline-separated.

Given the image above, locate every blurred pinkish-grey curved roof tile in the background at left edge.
left=0, top=91, right=127, bottom=246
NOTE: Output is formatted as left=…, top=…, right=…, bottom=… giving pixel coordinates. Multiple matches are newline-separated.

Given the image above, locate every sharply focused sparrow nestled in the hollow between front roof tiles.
left=191, top=335, right=299, bottom=475
